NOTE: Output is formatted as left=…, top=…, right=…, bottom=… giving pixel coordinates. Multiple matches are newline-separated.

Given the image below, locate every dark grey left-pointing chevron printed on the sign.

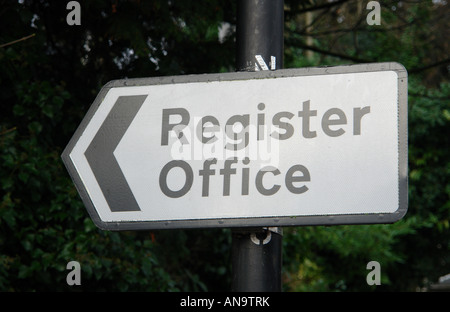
left=84, top=95, right=147, bottom=212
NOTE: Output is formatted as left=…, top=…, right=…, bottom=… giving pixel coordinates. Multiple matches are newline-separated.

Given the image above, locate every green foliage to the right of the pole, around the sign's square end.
left=284, top=1, right=450, bottom=290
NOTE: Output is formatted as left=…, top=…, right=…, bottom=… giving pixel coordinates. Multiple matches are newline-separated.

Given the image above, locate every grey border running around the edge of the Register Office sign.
left=61, top=62, right=408, bottom=231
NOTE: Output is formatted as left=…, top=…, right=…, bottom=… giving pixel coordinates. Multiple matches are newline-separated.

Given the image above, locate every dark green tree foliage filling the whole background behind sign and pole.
left=0, top=0, right=450, bottom=291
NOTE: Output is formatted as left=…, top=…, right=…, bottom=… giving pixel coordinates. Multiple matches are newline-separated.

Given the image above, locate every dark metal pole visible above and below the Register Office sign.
left=232, top=0, right=284, bottom=292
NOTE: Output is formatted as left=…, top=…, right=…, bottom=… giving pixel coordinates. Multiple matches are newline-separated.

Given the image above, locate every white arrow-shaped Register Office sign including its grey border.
left=62, top=63, right=407, bottom=230
